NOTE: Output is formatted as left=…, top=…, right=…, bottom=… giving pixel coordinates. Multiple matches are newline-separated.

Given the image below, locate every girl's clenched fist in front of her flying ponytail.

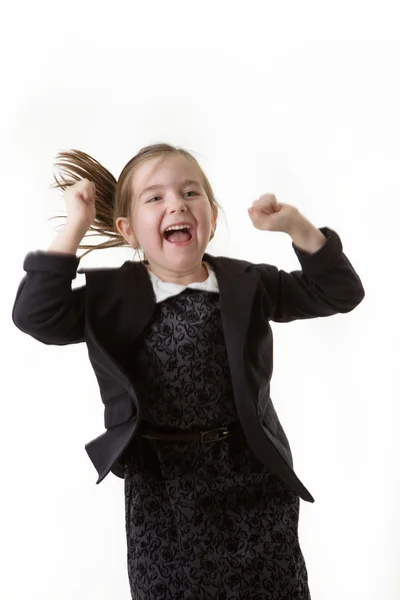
left=64, top=179, right=96, bottom=233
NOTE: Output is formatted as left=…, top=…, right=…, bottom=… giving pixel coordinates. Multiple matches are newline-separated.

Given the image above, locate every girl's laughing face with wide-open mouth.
left=117, top=154, right=216, bottom=280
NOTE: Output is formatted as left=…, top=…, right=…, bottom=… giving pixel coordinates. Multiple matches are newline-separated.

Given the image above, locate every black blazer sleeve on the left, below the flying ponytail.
left=12, top=250, right=86, bottom=346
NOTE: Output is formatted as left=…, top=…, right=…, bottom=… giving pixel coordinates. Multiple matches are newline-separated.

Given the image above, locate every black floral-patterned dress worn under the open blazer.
left=122, top=264, right=310, bottom=600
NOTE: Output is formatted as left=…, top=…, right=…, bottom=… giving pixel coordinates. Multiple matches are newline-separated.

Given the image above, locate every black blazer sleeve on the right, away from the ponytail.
left=255, top=227, right=365, bottom=323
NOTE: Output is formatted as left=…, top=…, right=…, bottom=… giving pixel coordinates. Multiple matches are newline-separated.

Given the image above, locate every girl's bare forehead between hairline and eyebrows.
left=133, top=154, right=200, bottom=196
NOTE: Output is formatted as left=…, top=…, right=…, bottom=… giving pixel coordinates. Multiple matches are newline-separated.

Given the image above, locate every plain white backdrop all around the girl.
left=0, top=0, right=400, bottom=600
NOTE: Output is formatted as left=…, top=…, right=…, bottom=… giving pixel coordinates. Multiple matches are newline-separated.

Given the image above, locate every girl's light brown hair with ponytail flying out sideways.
left=50, top=143, right=222, bottom=259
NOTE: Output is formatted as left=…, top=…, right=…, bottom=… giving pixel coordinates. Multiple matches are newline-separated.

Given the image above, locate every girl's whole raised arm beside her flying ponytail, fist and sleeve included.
left=12, top=179, right=96, bottom=346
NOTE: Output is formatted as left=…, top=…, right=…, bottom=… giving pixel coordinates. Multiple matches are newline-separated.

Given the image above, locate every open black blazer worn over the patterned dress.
left=12, top=227, right=364, bottom=502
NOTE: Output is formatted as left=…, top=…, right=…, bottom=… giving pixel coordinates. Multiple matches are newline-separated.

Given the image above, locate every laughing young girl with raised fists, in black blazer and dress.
left=13, top=144, right=364, bottom=600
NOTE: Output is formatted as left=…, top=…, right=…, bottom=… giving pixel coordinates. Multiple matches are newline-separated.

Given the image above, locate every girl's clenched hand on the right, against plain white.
left=247, top=194, right=300, bottom=233
